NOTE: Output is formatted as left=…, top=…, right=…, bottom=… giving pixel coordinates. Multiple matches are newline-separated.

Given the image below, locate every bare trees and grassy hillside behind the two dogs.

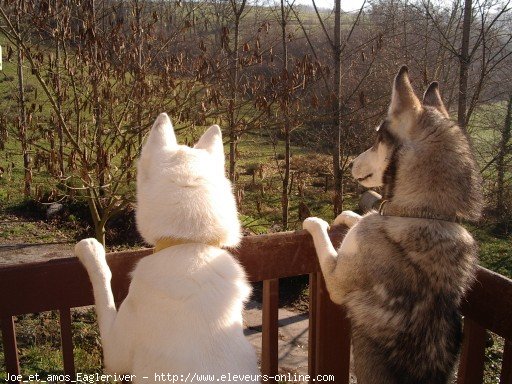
left=0, top=0, right=512, bottom=246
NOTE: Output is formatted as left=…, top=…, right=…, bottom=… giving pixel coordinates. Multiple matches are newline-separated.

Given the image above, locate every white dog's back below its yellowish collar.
left=126, top=244, right=258, bottom=378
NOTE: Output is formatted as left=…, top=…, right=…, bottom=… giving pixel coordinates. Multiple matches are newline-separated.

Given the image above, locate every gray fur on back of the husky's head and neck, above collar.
left=394, top=107, right=482, bottom=220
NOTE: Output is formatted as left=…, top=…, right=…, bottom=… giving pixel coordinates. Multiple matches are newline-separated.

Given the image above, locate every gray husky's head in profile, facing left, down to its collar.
left=352, top=66, right=482, bottom=220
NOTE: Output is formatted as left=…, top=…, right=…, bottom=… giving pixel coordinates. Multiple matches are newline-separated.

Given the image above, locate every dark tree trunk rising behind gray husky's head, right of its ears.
left=457, top=0, right=472, bottom=130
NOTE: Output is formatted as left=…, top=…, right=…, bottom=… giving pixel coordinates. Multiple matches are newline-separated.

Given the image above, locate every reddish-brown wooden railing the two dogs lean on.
left=0, top=228, right=512, bottom=384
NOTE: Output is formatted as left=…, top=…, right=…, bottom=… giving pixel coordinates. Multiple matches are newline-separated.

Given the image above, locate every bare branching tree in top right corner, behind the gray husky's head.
left=424, top=0, right=512, bottom=128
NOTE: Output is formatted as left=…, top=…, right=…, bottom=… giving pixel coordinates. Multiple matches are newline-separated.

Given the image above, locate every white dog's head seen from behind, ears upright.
left=136, top=113, right=240, bottom=246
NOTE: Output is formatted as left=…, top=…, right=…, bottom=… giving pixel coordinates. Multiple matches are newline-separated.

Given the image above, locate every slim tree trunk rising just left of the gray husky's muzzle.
left=332, top=0, right=343, bottom=217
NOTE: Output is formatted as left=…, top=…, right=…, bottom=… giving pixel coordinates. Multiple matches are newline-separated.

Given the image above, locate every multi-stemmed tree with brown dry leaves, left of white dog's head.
left=0, top=0, right=206, bottom=243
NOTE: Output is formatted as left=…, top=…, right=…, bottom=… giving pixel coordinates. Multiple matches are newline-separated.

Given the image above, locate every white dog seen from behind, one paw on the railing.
left=75, top=113, right=259, bottom=383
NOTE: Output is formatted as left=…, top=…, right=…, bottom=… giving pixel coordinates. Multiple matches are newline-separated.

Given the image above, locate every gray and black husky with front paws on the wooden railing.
left=304, top=67, right=482, bottom=384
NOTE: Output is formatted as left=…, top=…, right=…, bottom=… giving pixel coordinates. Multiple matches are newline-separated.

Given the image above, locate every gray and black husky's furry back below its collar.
left=345, top=215, right=477, bottom=384
